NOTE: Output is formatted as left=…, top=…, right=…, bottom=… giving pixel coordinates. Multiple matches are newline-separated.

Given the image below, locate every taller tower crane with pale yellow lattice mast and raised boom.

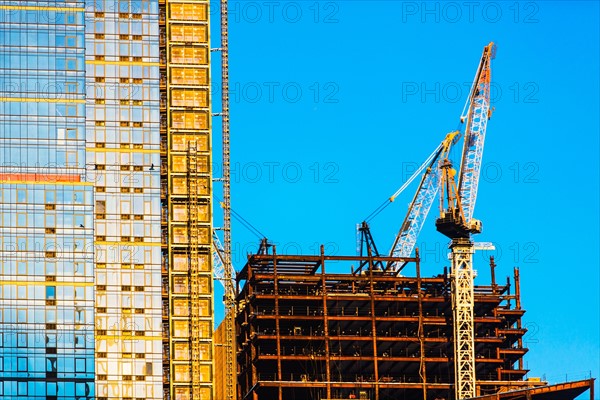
left=435, top=43, right=495, bottom=400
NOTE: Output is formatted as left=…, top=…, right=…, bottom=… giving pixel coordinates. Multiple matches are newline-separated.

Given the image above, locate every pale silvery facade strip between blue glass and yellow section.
left=85, top=0, right=162, bottom=399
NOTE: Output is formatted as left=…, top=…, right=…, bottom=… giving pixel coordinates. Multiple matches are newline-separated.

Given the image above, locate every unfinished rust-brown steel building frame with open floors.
left=234, top=248, right=592, bottom=400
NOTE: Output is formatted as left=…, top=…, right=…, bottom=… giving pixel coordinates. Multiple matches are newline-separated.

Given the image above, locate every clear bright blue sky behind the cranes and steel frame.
left=213, top=1, right=600, bottom=392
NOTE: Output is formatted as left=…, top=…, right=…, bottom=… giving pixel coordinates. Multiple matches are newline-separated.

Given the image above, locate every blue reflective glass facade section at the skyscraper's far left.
left=0, top=1, right=95, bottom=399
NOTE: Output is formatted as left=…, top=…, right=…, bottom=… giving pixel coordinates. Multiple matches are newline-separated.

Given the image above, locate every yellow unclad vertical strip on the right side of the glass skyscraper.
left=160, top=0, right=214, bottom=400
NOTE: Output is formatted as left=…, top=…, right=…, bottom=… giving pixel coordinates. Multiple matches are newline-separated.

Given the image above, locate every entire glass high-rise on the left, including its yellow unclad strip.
left=0, top=0, right=214, bottom=400
